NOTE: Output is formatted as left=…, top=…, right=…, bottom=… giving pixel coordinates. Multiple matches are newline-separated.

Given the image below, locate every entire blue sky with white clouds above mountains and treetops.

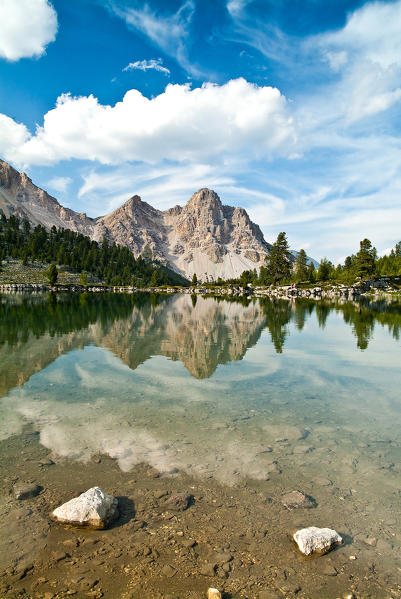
left=0, top=0, right=401, bottom=263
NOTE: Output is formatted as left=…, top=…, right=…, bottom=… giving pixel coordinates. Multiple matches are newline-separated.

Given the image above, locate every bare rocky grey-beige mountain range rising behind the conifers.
left=0, top=160, right=272, bottom=280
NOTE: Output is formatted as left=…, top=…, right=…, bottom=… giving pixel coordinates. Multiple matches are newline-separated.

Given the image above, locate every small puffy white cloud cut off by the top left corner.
left=0, top=0, right=57, bottom=61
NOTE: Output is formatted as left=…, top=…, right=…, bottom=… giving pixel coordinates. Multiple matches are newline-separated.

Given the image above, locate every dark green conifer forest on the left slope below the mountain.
left=0, top=215, right=188, bottom=287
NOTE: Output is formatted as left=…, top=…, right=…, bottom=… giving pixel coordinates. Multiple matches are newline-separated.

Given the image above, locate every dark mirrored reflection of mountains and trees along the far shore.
left=0, top=293, right=401, bottom=396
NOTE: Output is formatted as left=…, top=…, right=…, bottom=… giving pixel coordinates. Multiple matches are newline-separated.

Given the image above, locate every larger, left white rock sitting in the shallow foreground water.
left=51, top=487, right=118, bottom=529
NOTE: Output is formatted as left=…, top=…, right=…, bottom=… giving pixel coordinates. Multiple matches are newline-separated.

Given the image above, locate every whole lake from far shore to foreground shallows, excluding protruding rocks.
left=0, top=294, right=401, bottom=599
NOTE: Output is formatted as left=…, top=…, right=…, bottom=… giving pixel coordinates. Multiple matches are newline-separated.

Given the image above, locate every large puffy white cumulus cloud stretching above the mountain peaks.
left=4, top=79, right=295, bottom=165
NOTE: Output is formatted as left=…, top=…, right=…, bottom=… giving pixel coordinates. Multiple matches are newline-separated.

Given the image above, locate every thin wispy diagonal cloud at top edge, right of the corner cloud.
left=113, top=0, right=199, bottom=74
